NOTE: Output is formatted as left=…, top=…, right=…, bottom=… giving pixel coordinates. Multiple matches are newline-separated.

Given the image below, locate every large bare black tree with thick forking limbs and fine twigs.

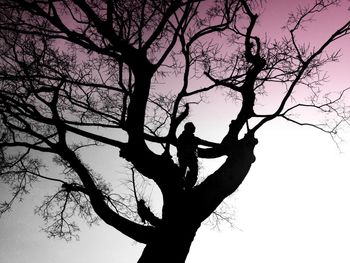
left=0, top=0, right=350, bottom=262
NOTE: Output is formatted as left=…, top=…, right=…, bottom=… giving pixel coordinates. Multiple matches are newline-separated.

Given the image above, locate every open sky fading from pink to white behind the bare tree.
left=0, top=0, right=350, bottom=263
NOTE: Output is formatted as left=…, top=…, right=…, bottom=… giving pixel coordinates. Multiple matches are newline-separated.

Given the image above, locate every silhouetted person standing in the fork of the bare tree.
left=177, top=122, right=216, bottom=189
